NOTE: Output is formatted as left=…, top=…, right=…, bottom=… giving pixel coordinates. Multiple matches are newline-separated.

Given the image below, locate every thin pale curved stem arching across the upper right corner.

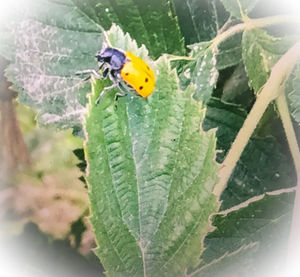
left=212, top=15, right=300, bottom=47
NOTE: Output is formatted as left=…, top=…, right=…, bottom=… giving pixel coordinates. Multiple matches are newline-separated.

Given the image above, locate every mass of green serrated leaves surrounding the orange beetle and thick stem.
left=0, top=0, right=300, bottom=277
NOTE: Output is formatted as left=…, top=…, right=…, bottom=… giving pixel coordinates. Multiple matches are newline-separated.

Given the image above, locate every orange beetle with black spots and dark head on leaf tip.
left=96, top=47, right=155, bottom=104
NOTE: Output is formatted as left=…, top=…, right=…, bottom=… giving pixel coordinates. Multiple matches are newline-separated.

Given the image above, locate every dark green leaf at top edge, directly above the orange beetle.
left=73, top=0, right=185, bottom=58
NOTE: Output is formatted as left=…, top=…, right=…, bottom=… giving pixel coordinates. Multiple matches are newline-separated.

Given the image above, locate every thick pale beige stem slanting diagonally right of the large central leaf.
left=213, top=42, right=300, bottom=197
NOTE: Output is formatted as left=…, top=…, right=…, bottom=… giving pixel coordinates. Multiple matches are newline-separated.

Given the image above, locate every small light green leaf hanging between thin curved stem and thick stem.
left=242, top=29, right=298, bottom=92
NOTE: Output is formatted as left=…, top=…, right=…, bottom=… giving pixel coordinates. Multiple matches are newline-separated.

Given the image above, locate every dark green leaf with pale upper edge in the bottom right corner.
left=191, top=191, right=295, bottom=277
